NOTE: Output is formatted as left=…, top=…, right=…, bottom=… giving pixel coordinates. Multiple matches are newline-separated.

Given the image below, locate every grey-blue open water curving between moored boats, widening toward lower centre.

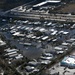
left=2, top=32, right=43, bottom=59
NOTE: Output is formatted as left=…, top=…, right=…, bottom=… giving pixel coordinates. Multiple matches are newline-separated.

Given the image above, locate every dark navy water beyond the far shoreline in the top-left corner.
left=0, top=0, right=44, bottom=11
